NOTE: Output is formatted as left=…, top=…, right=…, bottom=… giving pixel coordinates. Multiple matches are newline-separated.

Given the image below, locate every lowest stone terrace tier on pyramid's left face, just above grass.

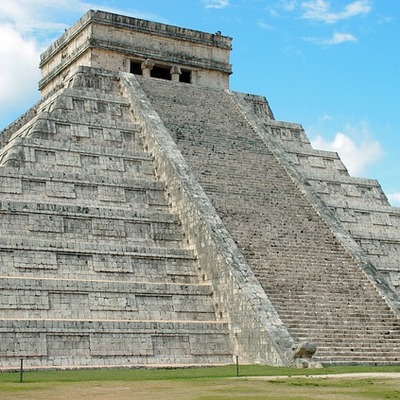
left=0, top=318, right=232, bottom=367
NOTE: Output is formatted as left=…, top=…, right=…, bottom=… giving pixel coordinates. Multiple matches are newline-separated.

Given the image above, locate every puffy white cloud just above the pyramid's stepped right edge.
left=311, top=127, right=383, bottom=176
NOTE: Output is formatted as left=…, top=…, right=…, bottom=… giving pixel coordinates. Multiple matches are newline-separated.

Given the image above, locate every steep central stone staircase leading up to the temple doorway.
left=138, top=77, right=400, bottom=364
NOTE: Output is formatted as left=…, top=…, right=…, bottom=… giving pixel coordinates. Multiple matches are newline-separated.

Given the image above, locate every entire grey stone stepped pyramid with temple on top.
left=0, top=10, right=400, bottom=370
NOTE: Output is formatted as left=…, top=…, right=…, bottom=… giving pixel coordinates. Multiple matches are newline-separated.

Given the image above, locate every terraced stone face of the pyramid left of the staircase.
left=0, top=69, right=232, bottom=368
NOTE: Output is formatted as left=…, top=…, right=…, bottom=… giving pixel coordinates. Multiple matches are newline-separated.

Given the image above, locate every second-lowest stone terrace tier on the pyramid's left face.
left=0, top=277, right=215, bottom=321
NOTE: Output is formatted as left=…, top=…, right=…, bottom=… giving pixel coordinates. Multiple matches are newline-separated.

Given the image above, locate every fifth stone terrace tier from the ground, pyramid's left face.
left=0, top=170, right=167, bottom=209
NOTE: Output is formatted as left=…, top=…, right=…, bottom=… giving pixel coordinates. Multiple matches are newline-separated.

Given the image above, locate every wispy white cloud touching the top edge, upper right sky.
left=301, top=0, right=372, bottom=24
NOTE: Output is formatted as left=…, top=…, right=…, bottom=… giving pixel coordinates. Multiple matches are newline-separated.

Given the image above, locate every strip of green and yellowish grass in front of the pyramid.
left=0, top=365, right=400, bottom=400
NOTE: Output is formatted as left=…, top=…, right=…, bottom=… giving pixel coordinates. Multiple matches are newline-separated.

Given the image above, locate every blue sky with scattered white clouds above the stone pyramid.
left=0, top=0, right=400, bottom=206
